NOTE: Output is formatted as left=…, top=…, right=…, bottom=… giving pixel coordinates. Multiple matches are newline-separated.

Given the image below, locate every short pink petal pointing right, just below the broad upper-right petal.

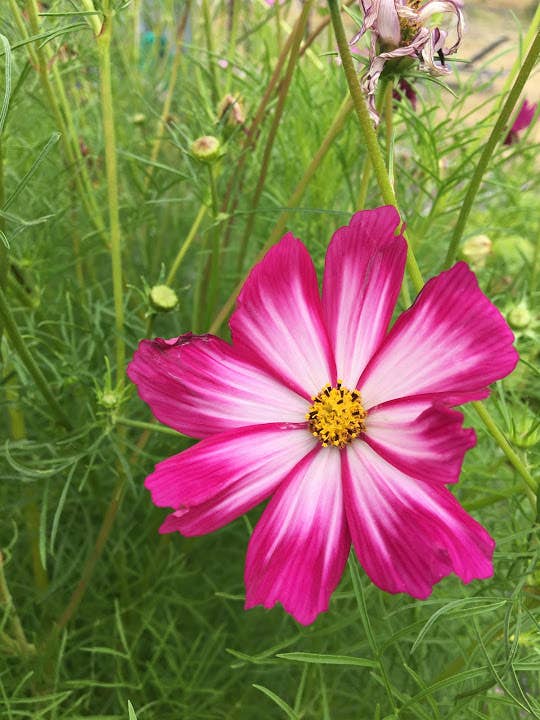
left=364, top=397, right=476, bottom=483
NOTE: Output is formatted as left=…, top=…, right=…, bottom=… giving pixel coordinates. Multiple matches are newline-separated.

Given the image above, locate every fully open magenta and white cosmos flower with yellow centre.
left=128, top=207, right=517, bottom=624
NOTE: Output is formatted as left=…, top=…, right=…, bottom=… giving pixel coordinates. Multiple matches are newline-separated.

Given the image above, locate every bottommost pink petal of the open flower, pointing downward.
left=245, top=448, right=350, bottom=625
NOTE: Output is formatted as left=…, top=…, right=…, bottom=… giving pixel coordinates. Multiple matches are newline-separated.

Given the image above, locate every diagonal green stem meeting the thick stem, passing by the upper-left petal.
left=209, top=97, right=352, bottom=333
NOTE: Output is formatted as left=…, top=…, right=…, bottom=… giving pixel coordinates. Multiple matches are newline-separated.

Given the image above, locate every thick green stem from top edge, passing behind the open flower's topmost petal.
left=328, top=0, right=424, bottom=292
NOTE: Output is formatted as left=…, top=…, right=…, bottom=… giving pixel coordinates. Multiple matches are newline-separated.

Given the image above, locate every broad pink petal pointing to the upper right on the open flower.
left=358, top=263, right=518, bottom=408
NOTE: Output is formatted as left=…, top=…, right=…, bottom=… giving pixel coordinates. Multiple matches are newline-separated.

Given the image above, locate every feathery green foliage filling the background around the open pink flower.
left=0, top=0, right=540, bottom=720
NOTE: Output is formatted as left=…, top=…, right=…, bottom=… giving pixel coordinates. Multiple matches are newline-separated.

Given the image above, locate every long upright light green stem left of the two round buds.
left=96, top=0, right=126, bottom=387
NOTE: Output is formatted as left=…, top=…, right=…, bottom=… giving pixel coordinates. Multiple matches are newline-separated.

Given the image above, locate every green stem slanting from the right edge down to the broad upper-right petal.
left=444, top=32, right=540, bottom=267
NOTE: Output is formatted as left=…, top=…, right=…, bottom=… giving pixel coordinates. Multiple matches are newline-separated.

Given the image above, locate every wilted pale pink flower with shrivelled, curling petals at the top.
left=351, top=0, right=464, bottom=122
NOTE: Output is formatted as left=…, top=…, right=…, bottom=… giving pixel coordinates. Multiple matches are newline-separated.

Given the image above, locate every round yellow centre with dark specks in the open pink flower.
left=306, top=380, right=367, bottom=448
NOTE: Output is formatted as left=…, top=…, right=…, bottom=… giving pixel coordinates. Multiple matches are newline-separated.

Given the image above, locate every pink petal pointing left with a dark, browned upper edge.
left=127, top=334, right=307, bottom=437
